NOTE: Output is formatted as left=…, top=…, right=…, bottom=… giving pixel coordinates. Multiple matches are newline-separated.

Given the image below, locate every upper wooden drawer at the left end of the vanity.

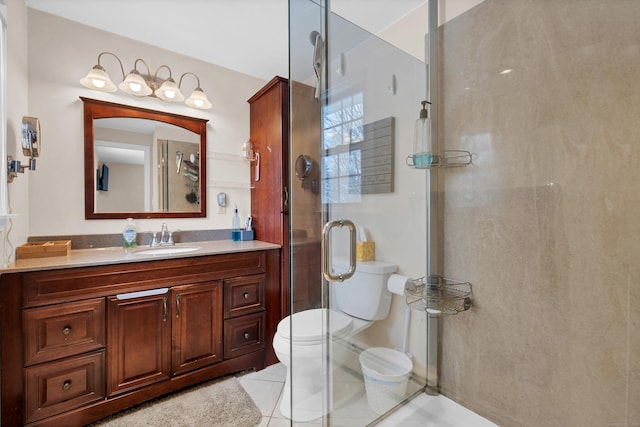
left=23, top=298, right=105, bottom=366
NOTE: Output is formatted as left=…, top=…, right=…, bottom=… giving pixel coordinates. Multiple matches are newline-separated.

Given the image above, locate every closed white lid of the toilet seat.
left=278, top=308, right=352, bottom=342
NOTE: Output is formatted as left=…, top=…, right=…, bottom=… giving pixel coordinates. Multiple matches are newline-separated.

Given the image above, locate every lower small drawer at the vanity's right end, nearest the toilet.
left=224, top=312, right=265, bottom=359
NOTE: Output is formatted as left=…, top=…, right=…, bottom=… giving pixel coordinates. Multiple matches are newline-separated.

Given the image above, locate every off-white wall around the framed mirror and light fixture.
left=23, top=10, right=265, bottom=243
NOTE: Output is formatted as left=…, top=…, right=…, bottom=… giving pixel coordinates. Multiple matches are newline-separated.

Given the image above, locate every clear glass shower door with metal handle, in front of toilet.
left=288, top=0, right=428, bottom=426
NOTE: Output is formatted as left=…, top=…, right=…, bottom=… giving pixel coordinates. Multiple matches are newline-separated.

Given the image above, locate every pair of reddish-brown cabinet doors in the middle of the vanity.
left=107, top=281, right=228, bottom=396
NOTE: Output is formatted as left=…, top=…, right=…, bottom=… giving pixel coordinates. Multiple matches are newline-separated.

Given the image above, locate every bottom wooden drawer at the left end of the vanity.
left=24, top=351, right=105, bottom=422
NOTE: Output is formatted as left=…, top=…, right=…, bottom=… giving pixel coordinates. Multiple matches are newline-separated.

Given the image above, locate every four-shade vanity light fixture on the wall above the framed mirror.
left=80, top=52, right=212, bottom=110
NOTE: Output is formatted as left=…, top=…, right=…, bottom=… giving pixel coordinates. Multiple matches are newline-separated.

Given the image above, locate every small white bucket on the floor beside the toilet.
left=360, top=347, right=413, bottom=414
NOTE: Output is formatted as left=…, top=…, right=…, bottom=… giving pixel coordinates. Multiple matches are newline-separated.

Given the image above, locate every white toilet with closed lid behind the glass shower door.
left=273, top=261, right=396, bottom=421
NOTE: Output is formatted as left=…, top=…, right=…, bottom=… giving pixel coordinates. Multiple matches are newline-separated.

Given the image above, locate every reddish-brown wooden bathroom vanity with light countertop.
left=0, top=241, right=281, bottom=426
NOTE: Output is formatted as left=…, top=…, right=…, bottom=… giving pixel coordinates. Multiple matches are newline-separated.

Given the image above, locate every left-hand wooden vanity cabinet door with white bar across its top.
left=107, top=288, right=171, bottom=396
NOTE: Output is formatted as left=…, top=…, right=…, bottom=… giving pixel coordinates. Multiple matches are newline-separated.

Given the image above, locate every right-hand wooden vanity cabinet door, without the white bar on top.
left=171, top=281, right=222, bottom=375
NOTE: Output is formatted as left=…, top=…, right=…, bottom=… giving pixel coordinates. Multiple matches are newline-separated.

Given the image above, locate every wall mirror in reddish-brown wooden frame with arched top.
left=81, top=97, right=207, bottom=219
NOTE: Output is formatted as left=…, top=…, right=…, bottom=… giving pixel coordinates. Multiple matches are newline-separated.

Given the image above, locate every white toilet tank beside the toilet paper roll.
left=332, top=260, right=397, bottom=320
